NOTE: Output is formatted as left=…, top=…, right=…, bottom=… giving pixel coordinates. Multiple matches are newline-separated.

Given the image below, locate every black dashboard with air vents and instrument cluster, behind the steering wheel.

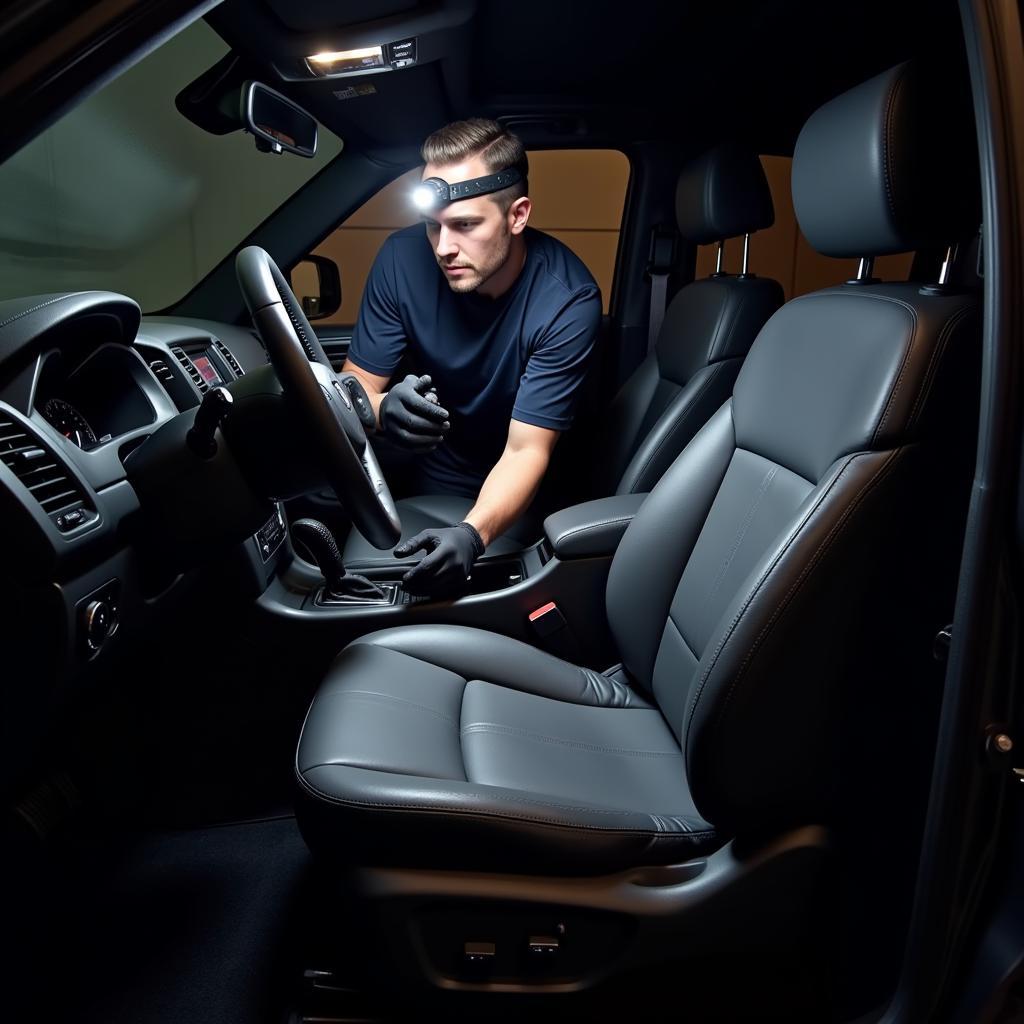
left=0, top=292, right=283, bottom=774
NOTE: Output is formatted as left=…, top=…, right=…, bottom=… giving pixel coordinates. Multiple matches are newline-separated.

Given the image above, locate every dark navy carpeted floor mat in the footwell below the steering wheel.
left=35, top=818, right=309, bottom=1024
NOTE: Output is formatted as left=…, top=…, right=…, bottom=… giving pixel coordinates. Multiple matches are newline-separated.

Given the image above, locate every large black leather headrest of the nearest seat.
left=793, top=62, right=980, bottom=257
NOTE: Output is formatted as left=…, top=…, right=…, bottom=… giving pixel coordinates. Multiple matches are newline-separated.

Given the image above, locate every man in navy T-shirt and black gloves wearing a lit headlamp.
left=343, top=119, right=601, bottom=595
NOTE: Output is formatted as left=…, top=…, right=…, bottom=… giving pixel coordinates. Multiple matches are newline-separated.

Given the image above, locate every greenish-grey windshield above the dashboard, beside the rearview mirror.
left=0, top=20, right=342, bottom=312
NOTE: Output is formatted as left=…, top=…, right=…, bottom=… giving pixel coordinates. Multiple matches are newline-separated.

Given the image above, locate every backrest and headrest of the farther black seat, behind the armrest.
left=597, top=143, right=783, bottom=495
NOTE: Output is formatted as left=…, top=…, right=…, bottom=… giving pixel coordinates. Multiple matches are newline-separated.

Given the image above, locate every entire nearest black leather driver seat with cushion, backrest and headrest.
left=296, top=65, right=980, bottom=979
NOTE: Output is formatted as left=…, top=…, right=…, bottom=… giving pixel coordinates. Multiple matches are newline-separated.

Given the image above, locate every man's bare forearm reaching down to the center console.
left=465, top=420, right=559, bottom=545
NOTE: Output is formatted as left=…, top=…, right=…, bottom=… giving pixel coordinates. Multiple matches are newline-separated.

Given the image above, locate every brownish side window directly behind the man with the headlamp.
left=299, top=150, right=630, bottom=326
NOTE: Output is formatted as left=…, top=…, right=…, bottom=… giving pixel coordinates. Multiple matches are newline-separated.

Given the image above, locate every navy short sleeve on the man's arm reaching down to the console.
left=512, top=287, right=601, bottom=430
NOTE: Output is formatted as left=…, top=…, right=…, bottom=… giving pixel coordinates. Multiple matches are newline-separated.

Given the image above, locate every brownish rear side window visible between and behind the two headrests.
left=696, top=157, right=913, bottom=301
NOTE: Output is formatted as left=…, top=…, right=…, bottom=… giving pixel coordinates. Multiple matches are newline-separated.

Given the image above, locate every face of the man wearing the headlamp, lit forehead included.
left=423, top=157, right=525, bottom=292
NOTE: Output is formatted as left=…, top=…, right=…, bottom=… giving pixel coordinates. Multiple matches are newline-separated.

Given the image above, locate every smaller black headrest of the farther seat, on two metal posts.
left=676, top=143, right=775, bottom=246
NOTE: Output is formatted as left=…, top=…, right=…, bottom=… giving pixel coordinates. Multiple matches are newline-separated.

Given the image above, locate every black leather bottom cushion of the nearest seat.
left=296, top=626, right=721, bottom=873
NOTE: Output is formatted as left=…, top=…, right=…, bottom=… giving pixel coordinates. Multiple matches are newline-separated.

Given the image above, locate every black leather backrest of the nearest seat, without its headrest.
left=607, top=285, right=978, bottom=828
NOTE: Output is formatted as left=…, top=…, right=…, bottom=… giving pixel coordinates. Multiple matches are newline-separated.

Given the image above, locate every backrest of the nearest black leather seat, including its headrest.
left=607, top=65, right=980, bottom=831
